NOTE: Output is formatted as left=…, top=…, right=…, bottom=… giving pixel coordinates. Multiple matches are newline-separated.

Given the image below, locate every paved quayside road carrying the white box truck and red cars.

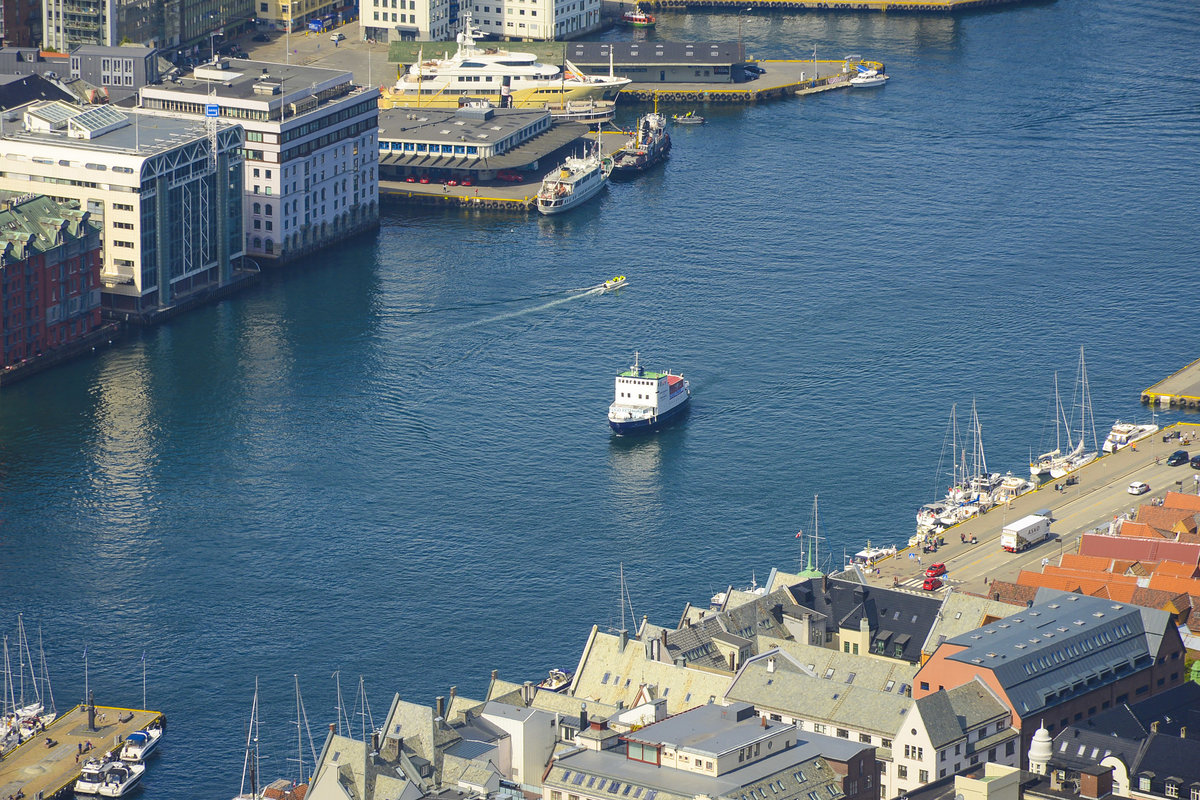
left=866, top=423, right=1200, bottom=594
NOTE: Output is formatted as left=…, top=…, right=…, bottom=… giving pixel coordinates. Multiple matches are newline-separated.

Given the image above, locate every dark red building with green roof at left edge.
left=0, top=194, right=101, bottom=367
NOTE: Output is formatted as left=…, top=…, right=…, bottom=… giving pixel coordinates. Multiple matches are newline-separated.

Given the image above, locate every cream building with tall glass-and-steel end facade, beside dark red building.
left=0, top=102, right=245, bottom=318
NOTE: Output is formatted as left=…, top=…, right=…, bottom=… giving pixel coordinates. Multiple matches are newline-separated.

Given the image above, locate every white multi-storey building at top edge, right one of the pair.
left=468, top=0, right=608, bottom=40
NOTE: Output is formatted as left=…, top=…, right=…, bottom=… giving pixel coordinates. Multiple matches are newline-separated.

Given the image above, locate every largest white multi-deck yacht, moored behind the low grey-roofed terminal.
left=379, top=14, right=631, bottom=108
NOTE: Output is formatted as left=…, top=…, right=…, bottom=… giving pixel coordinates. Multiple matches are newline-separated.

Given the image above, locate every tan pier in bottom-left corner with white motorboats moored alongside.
left=0, top=705, right=166, bottom=800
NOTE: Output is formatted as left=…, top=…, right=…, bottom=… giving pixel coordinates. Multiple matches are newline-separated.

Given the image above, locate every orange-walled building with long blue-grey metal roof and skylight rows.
left=913, top=590, right=1187, bottom=772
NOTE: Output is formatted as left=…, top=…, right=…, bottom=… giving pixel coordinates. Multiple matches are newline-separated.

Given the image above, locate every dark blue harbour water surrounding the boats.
left=0, top=0, right=1200, bottom=800
